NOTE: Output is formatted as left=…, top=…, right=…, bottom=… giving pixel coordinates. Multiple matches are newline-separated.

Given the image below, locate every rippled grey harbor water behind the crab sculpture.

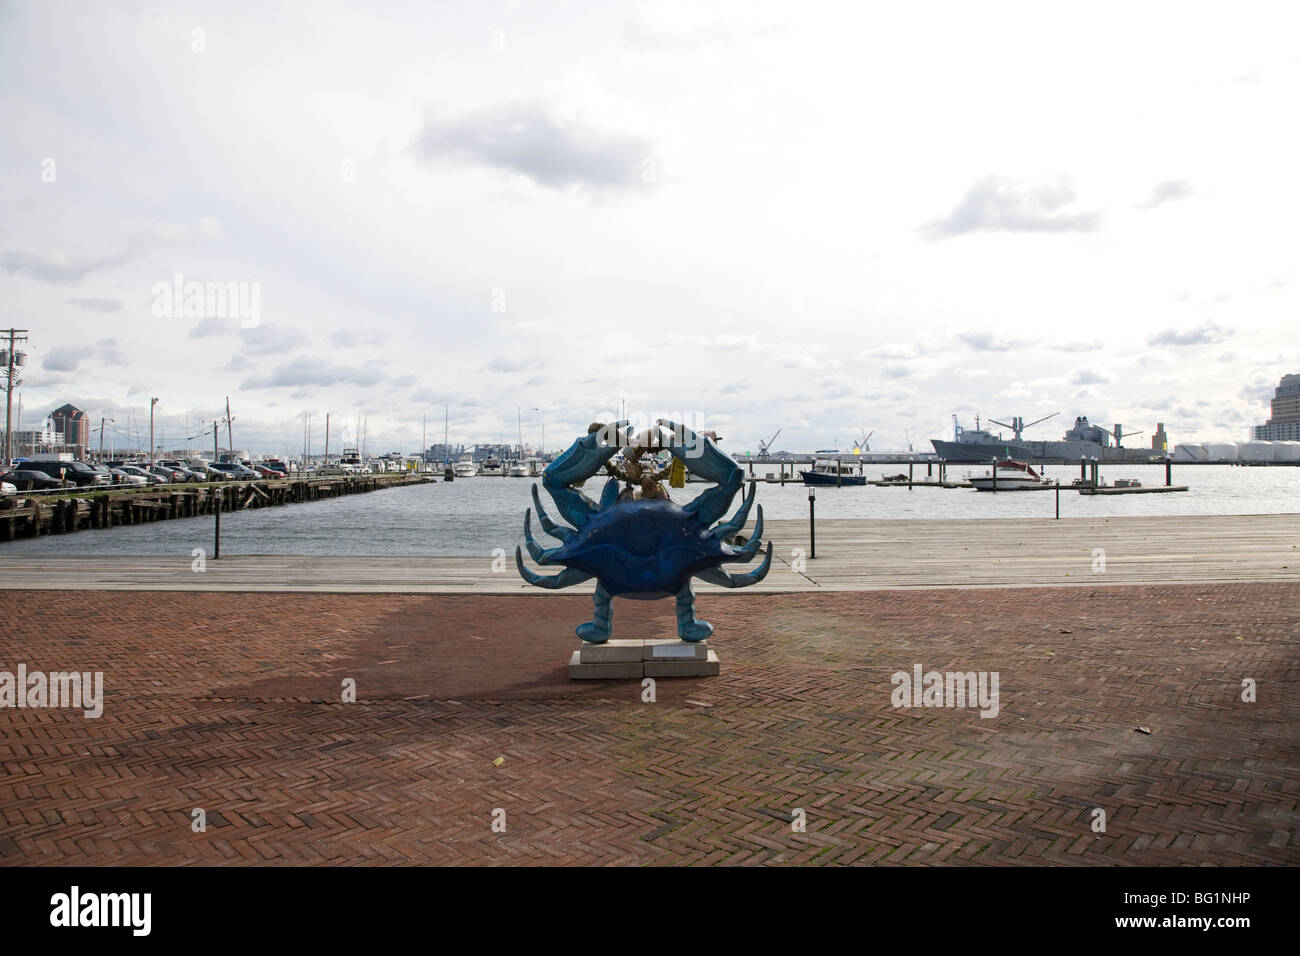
left=0, top=464, right=1300, bottom=555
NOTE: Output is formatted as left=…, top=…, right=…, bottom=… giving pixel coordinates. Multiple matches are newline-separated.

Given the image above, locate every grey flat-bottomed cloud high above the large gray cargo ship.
left=920, top=176, right=1101, bottom=241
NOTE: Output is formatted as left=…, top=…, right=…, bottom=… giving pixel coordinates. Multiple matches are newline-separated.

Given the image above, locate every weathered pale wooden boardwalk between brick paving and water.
left=0, top=515, right=1300, bottom=594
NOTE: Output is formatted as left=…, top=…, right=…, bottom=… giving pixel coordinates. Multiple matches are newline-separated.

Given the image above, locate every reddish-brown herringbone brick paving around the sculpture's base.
left=0, top=584, right=1300, bottom=865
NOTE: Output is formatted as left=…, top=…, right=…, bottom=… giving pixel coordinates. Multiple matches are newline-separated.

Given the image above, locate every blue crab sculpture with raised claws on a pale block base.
left=515, top=419, right=772, bottom=644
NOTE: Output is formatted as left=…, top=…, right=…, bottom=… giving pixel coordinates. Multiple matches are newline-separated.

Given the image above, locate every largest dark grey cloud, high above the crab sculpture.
left=412, top=90, right=657, bottom=190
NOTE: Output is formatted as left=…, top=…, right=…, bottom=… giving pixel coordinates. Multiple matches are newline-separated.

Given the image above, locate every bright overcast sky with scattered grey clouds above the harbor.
left=0, top=0, right=1300, bottom=454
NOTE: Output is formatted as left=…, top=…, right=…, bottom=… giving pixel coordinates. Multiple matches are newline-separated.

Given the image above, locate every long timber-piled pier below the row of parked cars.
left=0, top=473, right=432, bottom=541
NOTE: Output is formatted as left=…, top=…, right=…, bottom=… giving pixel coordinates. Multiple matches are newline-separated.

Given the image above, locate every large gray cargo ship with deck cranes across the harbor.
left=930, top=415, right=1156, bottom=464
